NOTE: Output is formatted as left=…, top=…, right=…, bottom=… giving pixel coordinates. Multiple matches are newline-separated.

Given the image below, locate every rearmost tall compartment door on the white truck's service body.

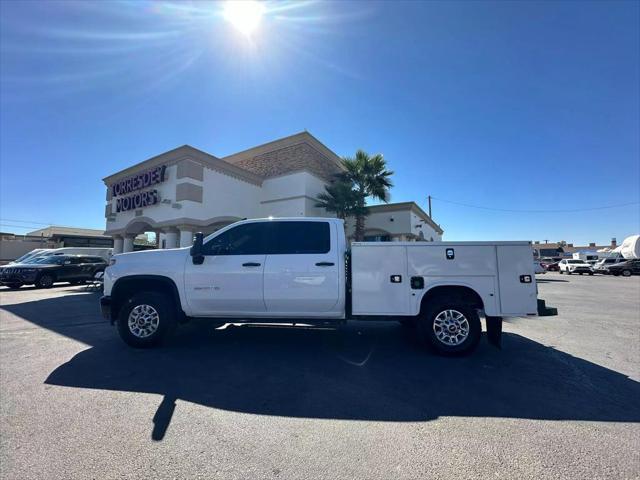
left=496, top=245, right=538, bottom=316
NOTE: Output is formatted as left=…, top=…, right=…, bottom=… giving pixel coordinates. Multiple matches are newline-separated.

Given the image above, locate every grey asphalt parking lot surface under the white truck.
left=0, top=273, right=640, bottom=479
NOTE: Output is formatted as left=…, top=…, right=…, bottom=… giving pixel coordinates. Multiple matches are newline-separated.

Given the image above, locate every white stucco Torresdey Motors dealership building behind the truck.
left=103, top=132, right=443, bottom=253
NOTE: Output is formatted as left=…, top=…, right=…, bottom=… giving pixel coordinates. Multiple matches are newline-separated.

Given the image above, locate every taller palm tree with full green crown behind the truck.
left=339, top=150, right=393, bottom=241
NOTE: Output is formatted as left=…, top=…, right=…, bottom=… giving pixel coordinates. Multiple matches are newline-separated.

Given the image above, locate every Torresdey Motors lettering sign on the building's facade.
left=109, top=165, right=167, bottom=212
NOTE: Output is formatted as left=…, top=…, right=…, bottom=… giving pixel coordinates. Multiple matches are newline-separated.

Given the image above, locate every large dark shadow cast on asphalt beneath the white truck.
left=2, top=294, right=640, bottom=440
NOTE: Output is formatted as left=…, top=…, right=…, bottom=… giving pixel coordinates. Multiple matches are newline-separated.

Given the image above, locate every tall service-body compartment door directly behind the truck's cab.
left=351, top=243, right=409, bottom=315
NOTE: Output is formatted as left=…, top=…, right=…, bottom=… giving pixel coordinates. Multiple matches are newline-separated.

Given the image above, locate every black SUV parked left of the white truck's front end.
left=0, top=255, right=107, bottom=289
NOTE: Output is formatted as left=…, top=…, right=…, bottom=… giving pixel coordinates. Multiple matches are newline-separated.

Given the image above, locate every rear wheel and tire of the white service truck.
left=418, top=299, right=482, bottom=356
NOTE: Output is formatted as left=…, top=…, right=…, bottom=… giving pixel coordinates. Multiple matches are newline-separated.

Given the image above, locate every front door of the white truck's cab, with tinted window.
left=184, top=222, right=270, bottom=317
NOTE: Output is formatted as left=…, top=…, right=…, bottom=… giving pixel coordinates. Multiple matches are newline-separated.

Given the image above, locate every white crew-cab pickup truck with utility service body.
left=100, top=218, right=555, bottom=355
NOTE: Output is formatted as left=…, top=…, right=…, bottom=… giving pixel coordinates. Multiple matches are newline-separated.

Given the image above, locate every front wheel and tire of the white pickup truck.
left=116, top=292, right=176, bottom=348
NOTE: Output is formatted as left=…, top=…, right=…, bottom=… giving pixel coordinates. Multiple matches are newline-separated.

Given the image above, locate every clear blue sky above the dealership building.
left=0, top=1, right=640, bottom=244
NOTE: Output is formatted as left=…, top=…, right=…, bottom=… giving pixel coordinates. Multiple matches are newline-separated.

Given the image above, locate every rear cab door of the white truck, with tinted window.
left=264, top=220, right=343, bottom=316
